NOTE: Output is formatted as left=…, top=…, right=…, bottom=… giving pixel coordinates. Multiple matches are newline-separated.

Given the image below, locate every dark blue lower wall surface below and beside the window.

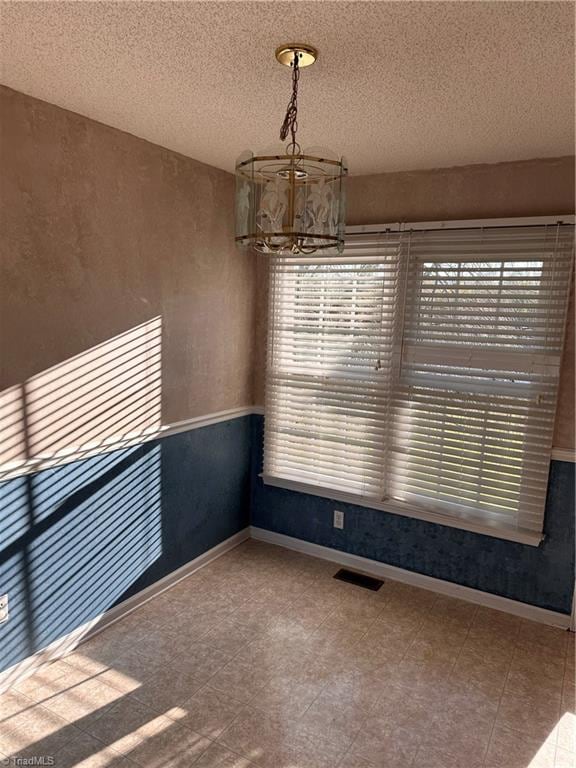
left=251, top=416, right=575, bottom=614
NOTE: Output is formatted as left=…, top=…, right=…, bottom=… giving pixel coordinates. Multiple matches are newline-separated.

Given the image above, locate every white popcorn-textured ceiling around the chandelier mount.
left=0, top=0, right=574, bottom=174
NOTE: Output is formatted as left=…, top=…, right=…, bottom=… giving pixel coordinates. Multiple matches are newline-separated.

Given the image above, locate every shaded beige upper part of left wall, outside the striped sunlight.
left=0, top=88, right=255, bottom=424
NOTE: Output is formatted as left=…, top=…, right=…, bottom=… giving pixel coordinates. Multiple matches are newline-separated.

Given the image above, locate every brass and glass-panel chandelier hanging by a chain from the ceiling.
left=236, top=43, right=347, bottom=256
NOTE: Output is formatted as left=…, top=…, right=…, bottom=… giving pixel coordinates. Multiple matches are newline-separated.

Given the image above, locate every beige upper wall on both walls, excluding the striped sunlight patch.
left=0, top=87, right=574, bottom=448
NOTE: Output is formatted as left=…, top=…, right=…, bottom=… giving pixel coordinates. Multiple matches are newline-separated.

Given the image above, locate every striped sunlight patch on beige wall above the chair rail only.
left=0, top=317, right=162, bottom=472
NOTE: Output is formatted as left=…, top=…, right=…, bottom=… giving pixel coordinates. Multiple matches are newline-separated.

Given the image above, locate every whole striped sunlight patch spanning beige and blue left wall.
left=0, top=317, right=162, bottom=680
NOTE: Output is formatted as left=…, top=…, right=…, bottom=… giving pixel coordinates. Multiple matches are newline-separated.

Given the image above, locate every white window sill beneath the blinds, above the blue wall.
left=260, top=474, right=544, bottom=547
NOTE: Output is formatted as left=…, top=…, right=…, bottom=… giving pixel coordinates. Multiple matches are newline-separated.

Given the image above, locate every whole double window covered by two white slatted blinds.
left=264, top=220, right=573, bottom=540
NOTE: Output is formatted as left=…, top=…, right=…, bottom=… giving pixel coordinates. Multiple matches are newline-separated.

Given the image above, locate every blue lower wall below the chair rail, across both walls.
left=0, top=408, right=574, bottom=671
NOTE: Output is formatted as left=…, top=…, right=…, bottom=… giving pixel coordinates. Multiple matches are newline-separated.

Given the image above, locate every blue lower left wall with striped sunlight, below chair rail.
left=0, top=416, right=251, bottom=671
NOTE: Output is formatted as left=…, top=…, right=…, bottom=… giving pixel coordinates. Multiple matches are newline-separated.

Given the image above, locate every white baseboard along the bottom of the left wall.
left=0, top=528, right=250, bottom=694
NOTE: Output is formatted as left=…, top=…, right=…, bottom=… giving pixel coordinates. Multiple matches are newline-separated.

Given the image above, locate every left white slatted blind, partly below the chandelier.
left=265, top=233, right=400, bottom=498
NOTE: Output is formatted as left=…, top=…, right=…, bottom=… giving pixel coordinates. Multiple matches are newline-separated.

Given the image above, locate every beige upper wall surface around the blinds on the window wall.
left=255, top=157, right=575, bottom=448
